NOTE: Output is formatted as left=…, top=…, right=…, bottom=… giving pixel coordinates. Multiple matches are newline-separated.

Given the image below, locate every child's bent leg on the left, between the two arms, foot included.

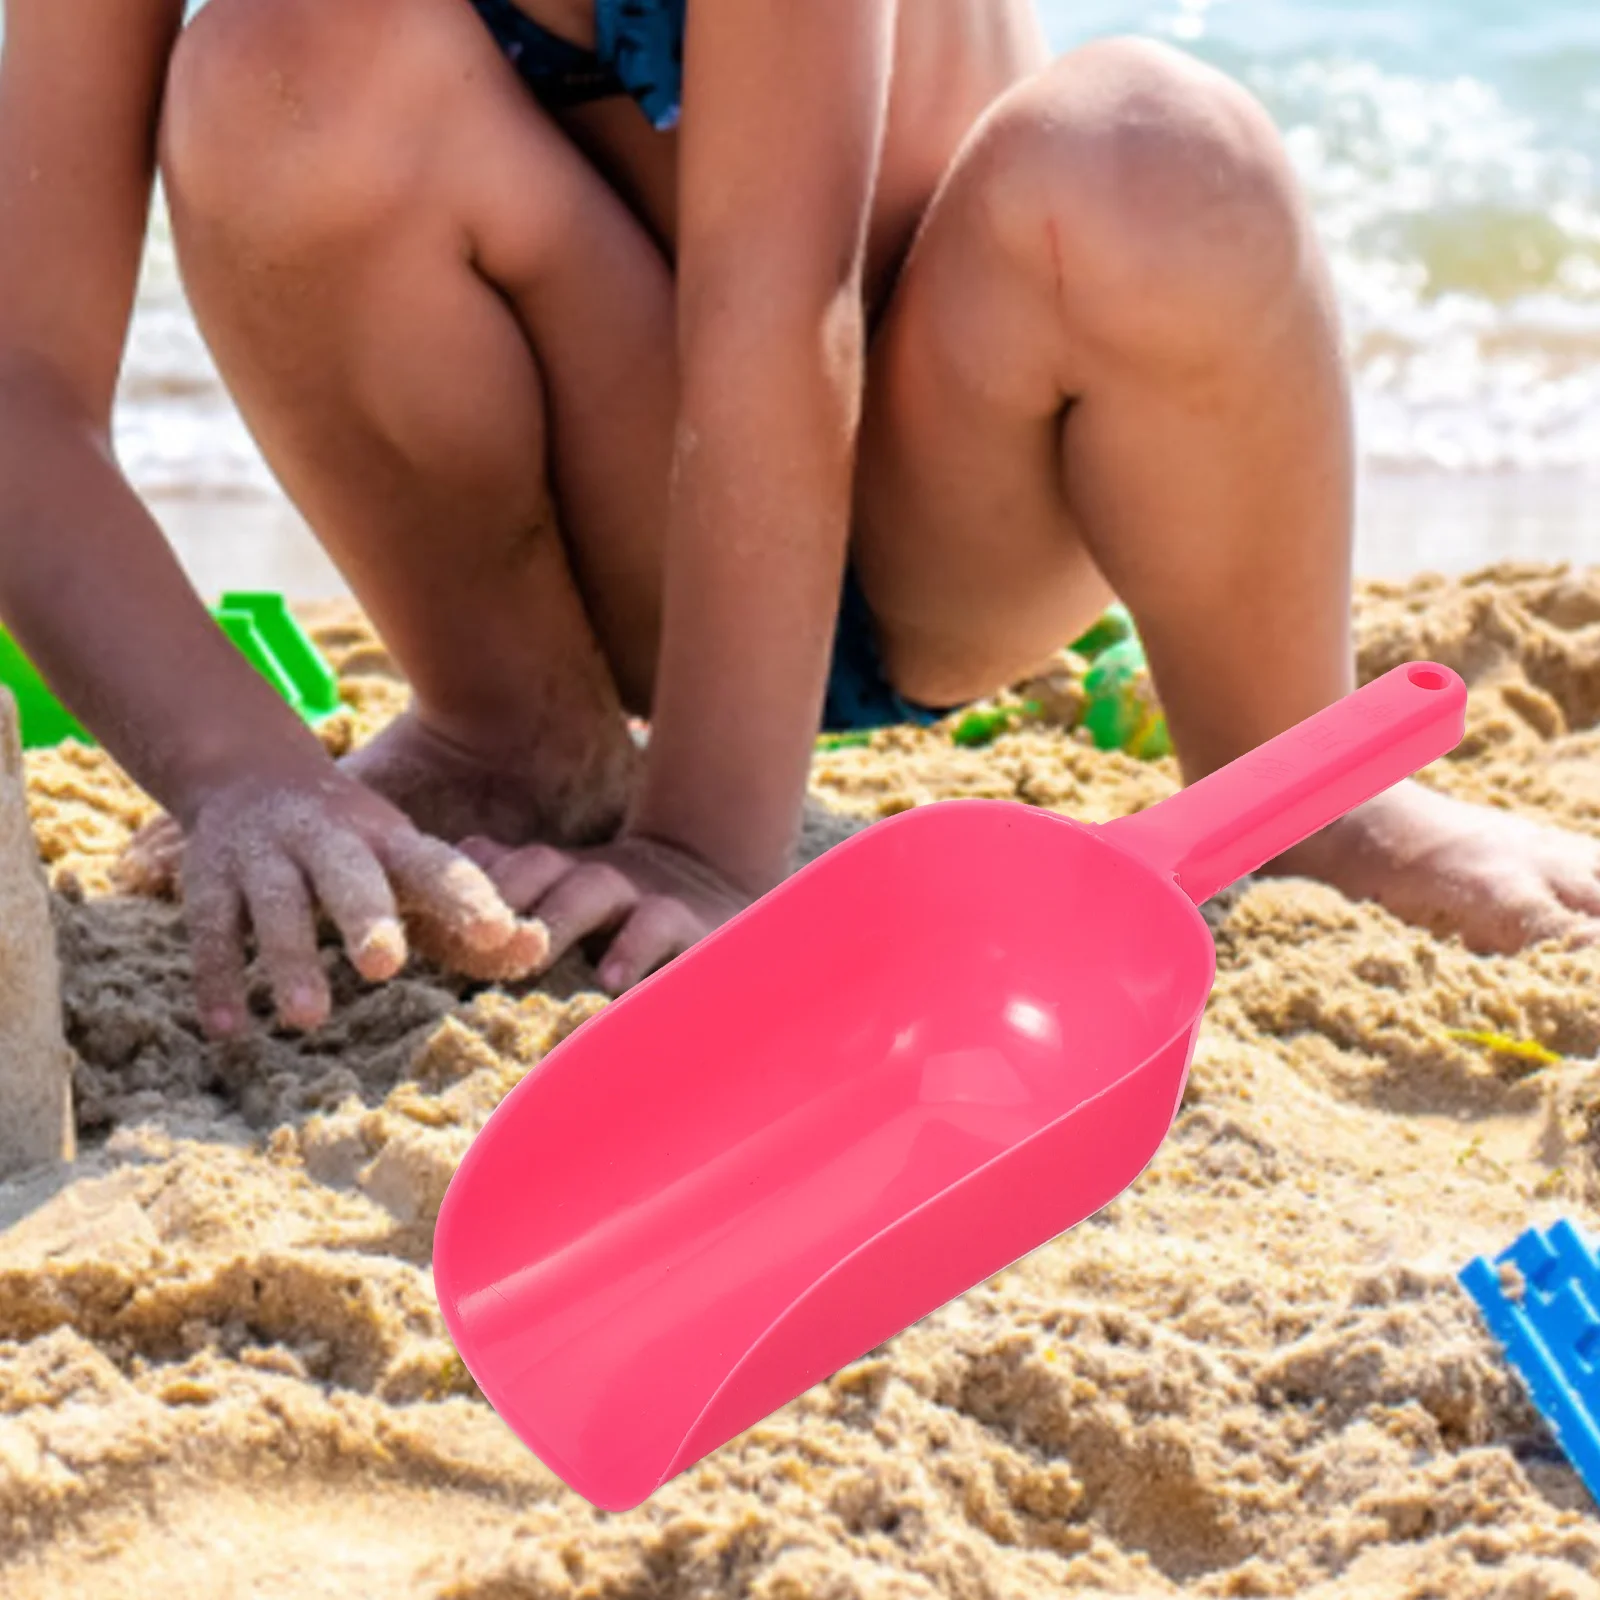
left=163, top=0, right=675, bottom=842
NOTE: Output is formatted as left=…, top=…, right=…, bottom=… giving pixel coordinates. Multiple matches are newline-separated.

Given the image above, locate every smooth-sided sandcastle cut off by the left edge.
left=0, top=688, right=75, bottom=1178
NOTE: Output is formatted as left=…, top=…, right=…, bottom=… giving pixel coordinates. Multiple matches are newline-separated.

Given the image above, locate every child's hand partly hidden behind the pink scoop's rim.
left=461, top=835, right=750, bottom=994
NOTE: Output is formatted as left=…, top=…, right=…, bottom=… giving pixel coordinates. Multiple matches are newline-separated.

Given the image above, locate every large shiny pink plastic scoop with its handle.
left=434, top=662, right=1466, bottom=1510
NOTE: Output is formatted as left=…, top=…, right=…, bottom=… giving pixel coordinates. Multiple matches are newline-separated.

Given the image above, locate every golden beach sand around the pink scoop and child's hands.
left=0, top=568, right=1600, bottom=1600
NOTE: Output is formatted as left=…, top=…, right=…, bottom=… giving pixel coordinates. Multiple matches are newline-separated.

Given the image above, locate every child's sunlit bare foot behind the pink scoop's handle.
left=1264, top=782, right=1600, bottom=954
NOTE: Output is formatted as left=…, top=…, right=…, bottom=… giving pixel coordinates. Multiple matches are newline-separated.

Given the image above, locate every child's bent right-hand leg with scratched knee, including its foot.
left=854, top=43, right=1600, bottom=947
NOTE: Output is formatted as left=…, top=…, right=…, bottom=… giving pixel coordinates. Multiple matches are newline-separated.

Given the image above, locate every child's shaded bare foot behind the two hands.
left=339, top=710, right=638, bottom=846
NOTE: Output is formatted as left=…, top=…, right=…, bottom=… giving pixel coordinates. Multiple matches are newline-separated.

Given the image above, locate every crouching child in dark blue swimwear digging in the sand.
left=0, top=0, right=1600, bottom=1035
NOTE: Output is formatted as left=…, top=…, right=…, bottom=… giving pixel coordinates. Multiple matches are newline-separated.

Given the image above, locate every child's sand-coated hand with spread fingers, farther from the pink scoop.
left=122, top=768, right=549, bottom=1038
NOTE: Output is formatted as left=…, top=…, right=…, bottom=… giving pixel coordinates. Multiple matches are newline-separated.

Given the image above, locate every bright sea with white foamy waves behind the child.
left=12, top=0, right=1600, bottom=598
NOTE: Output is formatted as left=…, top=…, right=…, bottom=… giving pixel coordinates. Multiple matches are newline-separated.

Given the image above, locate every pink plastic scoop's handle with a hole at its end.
left=1102, top=661, right=1467, bottom=906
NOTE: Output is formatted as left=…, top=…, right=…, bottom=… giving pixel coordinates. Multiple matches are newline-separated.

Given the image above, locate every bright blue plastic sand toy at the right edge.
left=1459, top=1219, right=1600, bottom=1501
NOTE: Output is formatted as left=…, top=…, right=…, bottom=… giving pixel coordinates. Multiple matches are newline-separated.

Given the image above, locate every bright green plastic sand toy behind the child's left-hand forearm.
left=0, top=592, right=339, bottom=750
